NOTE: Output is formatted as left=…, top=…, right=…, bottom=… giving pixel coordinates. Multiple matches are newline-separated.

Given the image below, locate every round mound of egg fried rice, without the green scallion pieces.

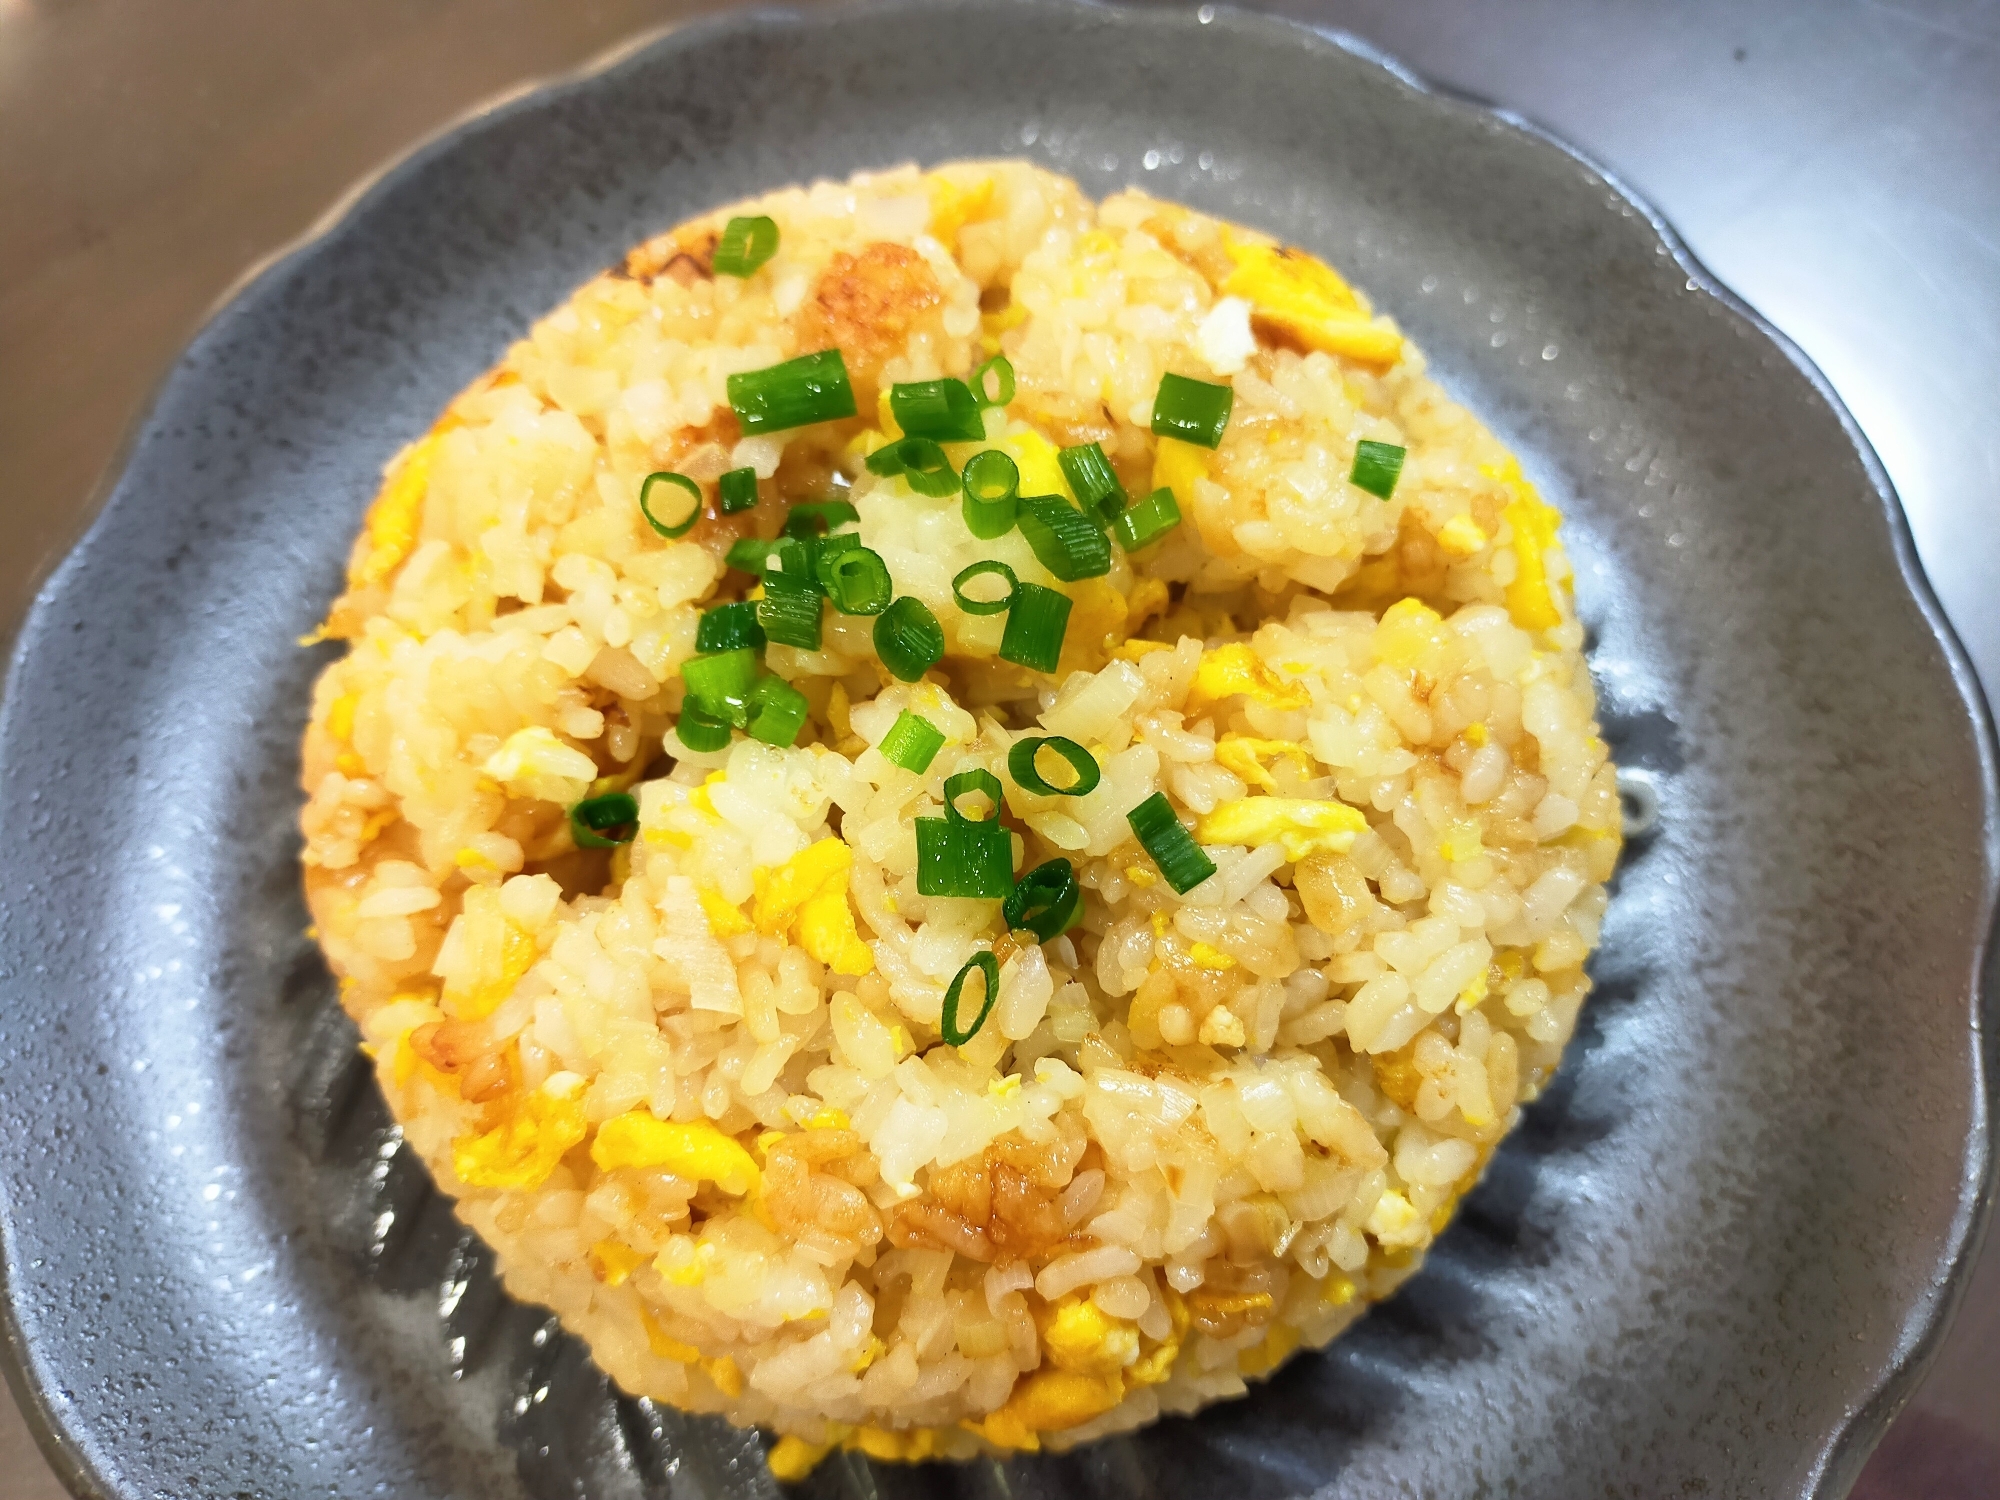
left=302, top=162, right=1620, bottom=1478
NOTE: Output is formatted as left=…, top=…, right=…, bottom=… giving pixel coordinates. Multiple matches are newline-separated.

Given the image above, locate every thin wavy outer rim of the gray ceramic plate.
left=0, top=0, right=2000, bottom=1500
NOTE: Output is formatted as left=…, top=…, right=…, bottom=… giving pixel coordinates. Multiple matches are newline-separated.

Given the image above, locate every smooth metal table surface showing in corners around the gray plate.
left=0, top=0, right=2000, bottom=1500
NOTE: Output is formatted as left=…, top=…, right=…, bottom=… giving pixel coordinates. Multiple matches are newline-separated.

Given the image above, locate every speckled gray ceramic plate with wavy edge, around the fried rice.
left=0, top=2, right=1996, bottom=1500
